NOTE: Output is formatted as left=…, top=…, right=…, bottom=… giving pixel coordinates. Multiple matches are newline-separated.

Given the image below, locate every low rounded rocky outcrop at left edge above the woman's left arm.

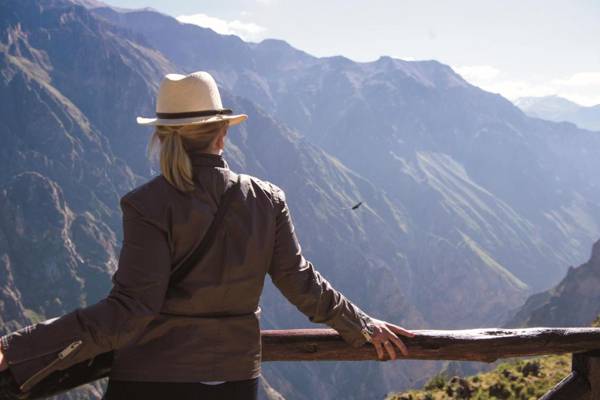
left=0, top=171, right=116, bottom=399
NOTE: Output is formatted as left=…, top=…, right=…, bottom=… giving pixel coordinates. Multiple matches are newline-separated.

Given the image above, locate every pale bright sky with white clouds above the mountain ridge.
left=104, top=0, right=600, bottom=106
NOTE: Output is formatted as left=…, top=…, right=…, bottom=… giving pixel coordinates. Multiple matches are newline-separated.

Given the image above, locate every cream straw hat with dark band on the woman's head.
left=137, top=71, right=248, bottom=126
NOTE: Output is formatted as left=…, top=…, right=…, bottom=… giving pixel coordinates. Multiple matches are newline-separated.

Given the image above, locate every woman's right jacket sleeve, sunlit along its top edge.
left=269, top=186, right=371, bottom=347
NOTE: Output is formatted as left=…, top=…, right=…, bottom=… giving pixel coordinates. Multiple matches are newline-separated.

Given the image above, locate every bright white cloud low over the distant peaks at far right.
left=452, top=65, right=600, bottom=106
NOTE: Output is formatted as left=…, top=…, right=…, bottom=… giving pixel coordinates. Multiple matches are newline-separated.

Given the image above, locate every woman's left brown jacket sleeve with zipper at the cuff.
left=1, top=195, right=171, bottom=386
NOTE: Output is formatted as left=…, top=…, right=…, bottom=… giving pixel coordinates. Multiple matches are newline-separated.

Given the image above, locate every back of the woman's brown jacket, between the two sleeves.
left=111, top=153, right=280, bottom=382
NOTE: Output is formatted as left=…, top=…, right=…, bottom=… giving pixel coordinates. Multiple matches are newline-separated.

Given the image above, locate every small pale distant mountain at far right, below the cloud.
left=515, top=96, right=600, bottom=131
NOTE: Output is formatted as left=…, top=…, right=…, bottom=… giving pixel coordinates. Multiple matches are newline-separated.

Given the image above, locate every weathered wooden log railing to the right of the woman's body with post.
left=262, top=328, right=600, bottom=400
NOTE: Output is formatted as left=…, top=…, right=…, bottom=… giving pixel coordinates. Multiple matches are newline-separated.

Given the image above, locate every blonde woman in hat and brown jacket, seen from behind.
left=0, top=71, right=412, bottom=400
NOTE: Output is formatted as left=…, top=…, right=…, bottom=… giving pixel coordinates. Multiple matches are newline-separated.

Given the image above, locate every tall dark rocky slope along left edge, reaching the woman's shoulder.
left=0, top=20, right=136, bottom=316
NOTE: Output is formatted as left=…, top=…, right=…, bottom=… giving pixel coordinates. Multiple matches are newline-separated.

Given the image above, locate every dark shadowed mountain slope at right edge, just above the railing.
left=507, top=240, right=600, bottom=327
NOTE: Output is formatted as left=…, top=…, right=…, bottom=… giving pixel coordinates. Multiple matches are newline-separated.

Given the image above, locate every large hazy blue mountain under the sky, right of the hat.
left=93, top=8, right=600, bottom=316
